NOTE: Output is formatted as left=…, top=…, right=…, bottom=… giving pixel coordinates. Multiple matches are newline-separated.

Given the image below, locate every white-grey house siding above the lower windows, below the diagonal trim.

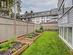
left=58, top=8, right=73, bottom=27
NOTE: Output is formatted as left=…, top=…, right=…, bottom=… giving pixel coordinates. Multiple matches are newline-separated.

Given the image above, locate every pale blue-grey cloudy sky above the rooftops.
left=21, top=0, right=58, bottom=14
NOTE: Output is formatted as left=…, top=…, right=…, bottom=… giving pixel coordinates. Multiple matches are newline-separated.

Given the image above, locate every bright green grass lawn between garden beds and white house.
left=21, top=31, right=70, bottom=55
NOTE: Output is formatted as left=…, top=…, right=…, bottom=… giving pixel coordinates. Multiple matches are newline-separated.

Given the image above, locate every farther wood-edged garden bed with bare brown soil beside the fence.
left=17, top=33, right=41, bottom=45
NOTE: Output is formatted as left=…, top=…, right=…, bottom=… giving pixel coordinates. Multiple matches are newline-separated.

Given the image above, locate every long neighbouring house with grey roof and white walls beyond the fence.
left=21, top=8, right=58, bottom=24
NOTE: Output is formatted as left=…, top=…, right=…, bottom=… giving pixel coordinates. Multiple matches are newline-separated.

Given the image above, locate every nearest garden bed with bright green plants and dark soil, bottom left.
left=0, top=41, right=23, bottom=55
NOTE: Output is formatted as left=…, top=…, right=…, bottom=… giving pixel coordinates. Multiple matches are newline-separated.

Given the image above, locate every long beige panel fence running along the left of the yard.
left=0, top=17, right=58, bottom=41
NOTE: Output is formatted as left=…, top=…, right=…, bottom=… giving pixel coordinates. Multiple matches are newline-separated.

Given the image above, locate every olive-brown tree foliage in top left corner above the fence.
left=0, top=0, right=14, bottom=15
